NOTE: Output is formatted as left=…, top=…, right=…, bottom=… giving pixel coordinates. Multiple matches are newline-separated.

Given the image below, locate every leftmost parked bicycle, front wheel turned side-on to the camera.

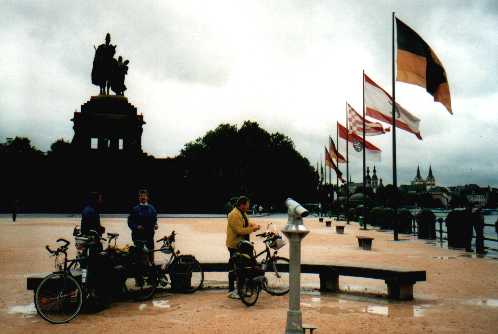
left=34, top=238, right=88, bottom=324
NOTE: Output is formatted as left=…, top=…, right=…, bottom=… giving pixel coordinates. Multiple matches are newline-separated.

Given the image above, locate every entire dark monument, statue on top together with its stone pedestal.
left=71, top=33, right=145, bottom=156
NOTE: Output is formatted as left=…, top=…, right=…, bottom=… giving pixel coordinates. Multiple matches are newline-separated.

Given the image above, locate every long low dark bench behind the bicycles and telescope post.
left=27, top=263, right=426, bottom=300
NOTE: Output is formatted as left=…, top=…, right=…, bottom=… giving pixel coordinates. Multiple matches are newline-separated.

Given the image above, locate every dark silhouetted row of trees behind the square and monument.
left=0, top=121, right=318, bottom=212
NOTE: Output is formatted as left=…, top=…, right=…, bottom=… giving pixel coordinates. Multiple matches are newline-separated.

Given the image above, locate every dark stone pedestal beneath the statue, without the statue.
left=71, top=95, right=145, bottom=154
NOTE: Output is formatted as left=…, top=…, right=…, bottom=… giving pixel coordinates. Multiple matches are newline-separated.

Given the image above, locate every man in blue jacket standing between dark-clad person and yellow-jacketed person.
left=128, top=190, right=157, bottom=262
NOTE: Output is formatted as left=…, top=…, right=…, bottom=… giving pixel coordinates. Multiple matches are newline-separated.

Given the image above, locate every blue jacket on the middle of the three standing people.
left=128, top=204, right=157, bottom=240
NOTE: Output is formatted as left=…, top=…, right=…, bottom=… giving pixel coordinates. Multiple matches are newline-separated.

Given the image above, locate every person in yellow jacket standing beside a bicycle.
left=226, top=196, right=261, bottom=299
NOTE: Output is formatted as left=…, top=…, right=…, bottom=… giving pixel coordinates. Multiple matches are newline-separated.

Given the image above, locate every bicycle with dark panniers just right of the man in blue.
left=154, top=231, right=204, bottom=293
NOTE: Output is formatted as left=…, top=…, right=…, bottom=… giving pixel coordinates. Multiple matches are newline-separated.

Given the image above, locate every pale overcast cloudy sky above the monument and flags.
left=0, top=0, right=498, bottom=186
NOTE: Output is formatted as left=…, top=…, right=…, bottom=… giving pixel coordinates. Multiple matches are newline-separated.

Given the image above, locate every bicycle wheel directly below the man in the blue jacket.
left=123, top=263, right=158, bottom=301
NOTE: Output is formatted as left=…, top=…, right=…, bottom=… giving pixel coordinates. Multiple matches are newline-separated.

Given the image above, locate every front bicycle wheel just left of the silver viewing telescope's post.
left=263, top=257, right=289, bottom=296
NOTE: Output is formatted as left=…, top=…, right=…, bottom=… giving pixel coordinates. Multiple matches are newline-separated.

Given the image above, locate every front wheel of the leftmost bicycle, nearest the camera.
left=34, top=273, right=83, bottom=324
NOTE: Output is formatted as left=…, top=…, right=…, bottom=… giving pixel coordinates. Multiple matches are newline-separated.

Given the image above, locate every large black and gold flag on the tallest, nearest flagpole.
left=396, top=18, right=453, bottom=114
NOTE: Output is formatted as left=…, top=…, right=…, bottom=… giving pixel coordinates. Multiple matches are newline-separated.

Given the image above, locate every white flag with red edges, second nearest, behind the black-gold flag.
left=363, top=74, right=422, bottom=140
